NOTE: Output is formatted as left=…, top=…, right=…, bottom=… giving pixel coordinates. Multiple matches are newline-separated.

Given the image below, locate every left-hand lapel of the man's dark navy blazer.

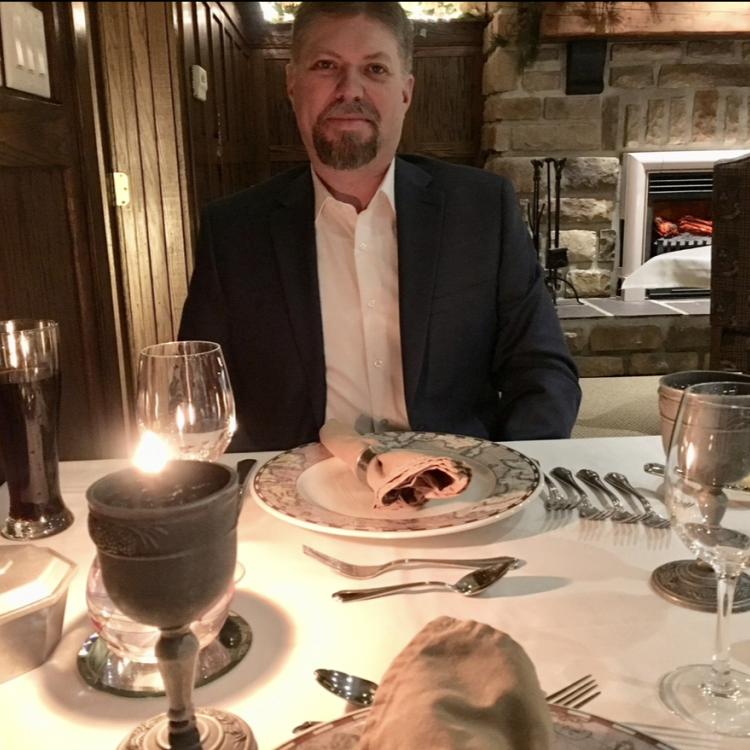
left=270, top=170, right=326, bottom=424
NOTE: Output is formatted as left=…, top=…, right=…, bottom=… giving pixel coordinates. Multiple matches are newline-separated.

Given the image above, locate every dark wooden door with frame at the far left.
left=0, top=3, right=125, bottom=459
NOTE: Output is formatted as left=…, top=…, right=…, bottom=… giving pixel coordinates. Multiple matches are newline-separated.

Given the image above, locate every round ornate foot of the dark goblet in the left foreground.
left=117, top=708, right=258, bottom=750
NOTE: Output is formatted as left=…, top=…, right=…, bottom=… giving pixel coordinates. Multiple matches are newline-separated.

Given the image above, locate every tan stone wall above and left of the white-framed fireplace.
left=482, top=3, right=750, bottom=297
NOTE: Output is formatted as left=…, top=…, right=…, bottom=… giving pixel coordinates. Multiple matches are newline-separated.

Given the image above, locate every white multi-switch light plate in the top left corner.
left=0, top=2, right=50, bottom=98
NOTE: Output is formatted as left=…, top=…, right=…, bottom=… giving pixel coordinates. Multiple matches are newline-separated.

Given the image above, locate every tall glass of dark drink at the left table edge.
left=0, top=320, right=73, bottom=539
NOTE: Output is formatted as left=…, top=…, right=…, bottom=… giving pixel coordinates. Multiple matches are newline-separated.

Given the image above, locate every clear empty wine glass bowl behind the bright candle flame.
left=136, top=341, right=237, bottom=461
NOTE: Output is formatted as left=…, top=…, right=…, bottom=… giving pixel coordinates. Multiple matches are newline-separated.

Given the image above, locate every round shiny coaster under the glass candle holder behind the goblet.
left=77, top=612, right=253, bottom=698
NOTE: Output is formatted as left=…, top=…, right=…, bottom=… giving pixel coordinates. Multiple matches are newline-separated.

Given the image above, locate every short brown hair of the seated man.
left=292, top=2, right=414, bottom=73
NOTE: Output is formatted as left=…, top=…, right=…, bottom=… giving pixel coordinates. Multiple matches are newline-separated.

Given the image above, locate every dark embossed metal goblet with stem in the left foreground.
left=86, top=461, right=256, bottom=750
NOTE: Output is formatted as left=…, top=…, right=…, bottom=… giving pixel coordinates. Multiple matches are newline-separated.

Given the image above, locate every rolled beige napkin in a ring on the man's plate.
left=320, top=419, right=471, bottom=508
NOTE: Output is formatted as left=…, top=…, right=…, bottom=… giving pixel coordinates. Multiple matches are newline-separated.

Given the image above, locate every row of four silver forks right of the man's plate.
left=544, top=466, right=670, bottom=529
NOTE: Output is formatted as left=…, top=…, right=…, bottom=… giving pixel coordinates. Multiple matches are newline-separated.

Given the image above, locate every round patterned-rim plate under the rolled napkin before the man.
left=251, top=432, right=540, bottom=539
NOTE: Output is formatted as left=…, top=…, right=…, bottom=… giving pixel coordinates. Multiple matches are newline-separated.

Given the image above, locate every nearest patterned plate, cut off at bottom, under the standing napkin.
left=276, top=706, right=675, bottom=750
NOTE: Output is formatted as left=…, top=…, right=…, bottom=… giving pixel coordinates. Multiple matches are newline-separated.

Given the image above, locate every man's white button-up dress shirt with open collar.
left=312, top=162, right=409, bottom=432
